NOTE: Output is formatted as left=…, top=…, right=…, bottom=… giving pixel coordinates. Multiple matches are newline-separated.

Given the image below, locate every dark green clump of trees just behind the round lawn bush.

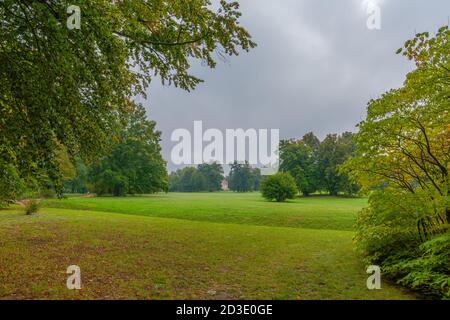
left=280, top=132, right=358, bottom=196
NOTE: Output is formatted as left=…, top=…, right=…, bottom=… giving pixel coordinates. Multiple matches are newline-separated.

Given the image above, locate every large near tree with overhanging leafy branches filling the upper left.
left=0, top=0, right=255, bottom=200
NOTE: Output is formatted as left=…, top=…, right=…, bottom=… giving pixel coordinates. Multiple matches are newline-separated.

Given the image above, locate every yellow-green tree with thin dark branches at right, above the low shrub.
left=346, top=27, right=450, bottom=238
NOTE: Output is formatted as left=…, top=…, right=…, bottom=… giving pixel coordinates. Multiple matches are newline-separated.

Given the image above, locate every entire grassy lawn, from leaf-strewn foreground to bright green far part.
left=0, top=193, right=414, bottom=299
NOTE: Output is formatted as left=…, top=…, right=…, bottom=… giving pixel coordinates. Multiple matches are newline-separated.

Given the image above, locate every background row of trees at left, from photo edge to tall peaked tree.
left=0, top=104, right=168, bottom=201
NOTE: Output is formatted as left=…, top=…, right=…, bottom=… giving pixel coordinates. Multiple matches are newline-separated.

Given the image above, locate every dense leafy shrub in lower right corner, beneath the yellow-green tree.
left=355, top=189, right=450, bottom=299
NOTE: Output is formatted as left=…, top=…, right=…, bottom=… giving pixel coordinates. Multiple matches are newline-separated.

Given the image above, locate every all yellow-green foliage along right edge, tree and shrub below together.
left=342, top=27, right=450, bottom=298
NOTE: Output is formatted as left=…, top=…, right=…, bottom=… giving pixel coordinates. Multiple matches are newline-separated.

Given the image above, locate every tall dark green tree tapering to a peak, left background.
left=64, top=106, right=168, bottom=196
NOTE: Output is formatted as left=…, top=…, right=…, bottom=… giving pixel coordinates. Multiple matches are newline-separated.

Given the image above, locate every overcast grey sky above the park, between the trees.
left=143, top=0, right=450, bottom=169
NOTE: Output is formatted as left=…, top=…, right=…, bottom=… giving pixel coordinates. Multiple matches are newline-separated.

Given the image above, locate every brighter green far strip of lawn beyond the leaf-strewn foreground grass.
left=46, top=192, right=367, bottom=231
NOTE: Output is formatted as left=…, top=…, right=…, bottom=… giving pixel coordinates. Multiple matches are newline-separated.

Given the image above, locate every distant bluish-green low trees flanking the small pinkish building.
left=169, top=162, right=261, bottom=192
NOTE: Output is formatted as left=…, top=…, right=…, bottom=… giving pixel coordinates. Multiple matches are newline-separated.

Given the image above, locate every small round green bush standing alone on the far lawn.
left=261, top=172, right=297, bottom=202
